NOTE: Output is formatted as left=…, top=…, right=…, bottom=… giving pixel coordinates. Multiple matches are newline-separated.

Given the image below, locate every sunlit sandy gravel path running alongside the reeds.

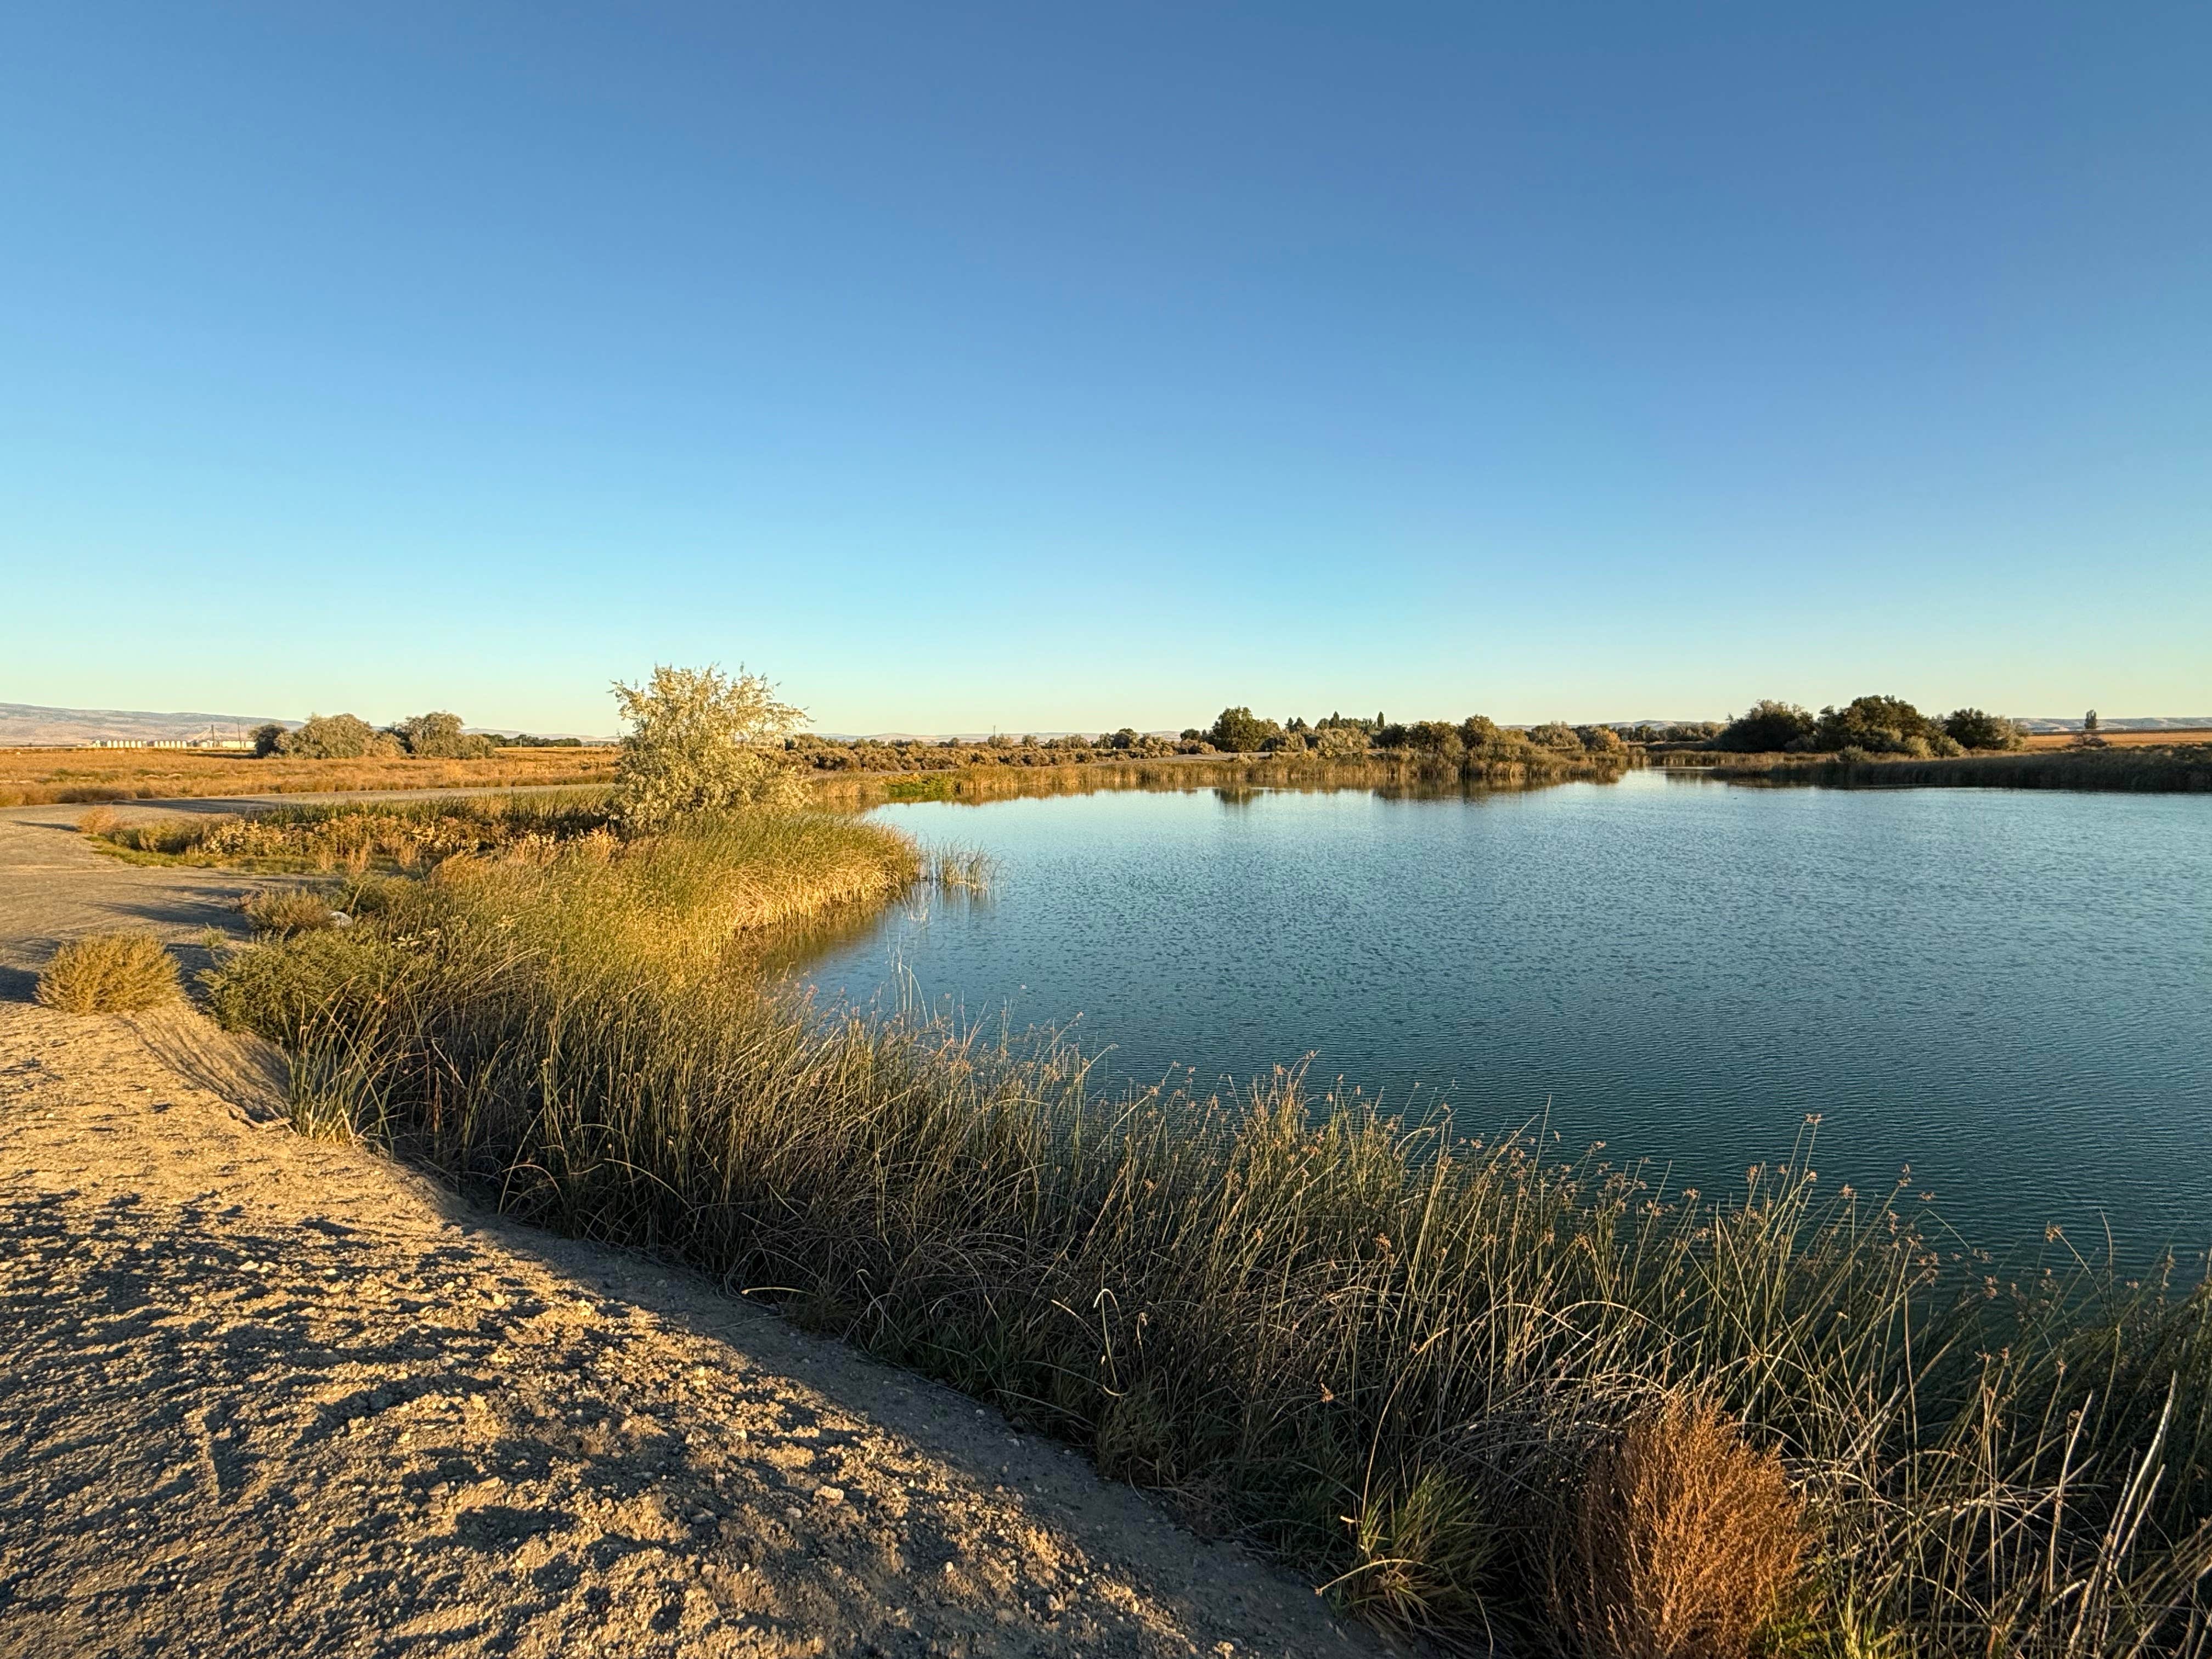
left=0, top=810, right=1385, bottom=1659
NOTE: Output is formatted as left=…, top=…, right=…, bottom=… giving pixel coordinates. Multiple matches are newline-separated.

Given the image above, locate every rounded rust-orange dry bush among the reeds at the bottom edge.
left=1568, top=1398, right=1807, bottom=1659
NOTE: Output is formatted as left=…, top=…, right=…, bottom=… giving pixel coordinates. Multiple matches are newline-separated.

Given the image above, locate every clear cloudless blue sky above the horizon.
left=0, top=0, right=2212, bottom=730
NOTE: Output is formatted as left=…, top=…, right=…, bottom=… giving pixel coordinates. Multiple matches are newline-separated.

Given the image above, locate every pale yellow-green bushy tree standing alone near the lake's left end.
left=615, top=666, right=805, bottom=836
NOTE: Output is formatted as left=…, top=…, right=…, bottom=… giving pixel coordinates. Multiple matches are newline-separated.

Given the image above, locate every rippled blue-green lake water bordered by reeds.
left=803, top=772, right=2212, bottom=1256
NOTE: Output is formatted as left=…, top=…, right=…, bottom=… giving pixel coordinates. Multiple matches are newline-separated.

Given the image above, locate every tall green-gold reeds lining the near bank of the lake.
left=212, top=821, right=2212, bottom=1659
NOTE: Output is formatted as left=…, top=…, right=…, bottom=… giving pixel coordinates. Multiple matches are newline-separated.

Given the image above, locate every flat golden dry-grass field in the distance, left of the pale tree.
left=0, top=748, right=615, bottom=808
